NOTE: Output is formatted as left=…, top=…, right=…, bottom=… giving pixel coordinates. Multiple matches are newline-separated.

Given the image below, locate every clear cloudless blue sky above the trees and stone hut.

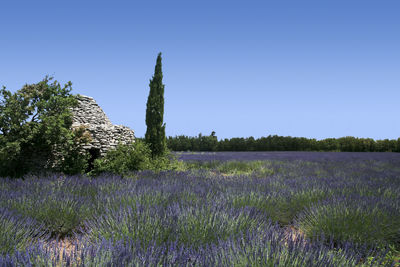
left=0, top=0, right=400, bottom=139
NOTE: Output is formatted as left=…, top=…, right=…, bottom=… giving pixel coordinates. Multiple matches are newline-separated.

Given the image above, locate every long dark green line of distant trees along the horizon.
left=167, top=132, right=400, bottom=152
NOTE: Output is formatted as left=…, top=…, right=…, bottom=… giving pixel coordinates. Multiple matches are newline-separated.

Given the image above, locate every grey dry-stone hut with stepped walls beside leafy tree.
left=72, top=95, right=135, bottom=156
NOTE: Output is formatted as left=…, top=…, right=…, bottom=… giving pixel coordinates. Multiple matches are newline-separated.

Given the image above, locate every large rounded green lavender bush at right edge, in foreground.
left=297, top=195, right=400, bottom=247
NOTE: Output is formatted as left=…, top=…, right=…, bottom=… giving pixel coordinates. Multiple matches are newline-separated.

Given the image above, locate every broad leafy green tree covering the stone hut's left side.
left=0, top=76, right=88, bottom=177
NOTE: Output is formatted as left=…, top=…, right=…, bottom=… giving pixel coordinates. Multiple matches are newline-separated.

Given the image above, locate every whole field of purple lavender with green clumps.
left=0, top=152, right=400, bottom=266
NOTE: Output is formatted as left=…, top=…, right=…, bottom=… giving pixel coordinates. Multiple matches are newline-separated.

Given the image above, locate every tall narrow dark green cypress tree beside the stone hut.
left=145, top=53, right=167, bottom=158
